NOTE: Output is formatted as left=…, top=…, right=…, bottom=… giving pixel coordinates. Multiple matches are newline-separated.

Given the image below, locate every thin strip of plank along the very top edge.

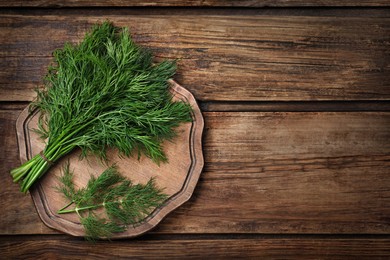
left=0, top=0, right=390, bottom=7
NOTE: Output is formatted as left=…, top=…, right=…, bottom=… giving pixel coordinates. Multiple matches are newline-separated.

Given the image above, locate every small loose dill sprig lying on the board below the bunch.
left=57, top=163, right=168, bottom=240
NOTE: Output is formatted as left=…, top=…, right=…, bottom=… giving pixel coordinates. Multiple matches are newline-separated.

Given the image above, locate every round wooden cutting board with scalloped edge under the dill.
left=16, top=81, right=204, bottom=238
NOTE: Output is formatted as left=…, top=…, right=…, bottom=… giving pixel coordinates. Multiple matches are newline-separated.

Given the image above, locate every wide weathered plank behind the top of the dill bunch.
left=0, top=12, right=390, bottom=101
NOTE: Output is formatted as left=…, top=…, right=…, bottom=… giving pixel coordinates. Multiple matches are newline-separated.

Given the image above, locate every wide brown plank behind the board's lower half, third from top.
left=0, top=110, right=390, bottom=234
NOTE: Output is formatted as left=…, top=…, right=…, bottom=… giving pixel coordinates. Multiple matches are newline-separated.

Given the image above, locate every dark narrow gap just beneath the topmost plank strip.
left=0, top=6, right=390, bottom=18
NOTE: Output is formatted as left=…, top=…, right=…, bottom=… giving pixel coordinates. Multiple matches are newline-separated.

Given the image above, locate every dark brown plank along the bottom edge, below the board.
left=0, top=236, right=390, bottom=259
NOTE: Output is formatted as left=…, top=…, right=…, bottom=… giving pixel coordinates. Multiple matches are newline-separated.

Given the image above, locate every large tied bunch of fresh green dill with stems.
left=11, top=22, right=191, bottom=192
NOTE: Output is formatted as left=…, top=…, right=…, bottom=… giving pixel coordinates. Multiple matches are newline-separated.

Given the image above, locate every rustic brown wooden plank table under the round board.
left=0, top=0, right=390, bottom=259
